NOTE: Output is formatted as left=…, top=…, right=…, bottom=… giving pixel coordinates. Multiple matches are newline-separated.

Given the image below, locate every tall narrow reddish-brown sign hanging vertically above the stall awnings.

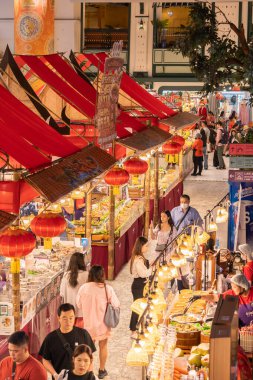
left=95, top=41, right=124, bottom=148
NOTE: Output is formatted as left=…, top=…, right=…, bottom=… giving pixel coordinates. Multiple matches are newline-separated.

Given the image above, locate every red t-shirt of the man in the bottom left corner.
left=0, top=356, right=47, bottom=380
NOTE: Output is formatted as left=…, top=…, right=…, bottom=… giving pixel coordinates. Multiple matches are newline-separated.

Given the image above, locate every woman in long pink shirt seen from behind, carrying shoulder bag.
left=76, top=265, right=120, bottom=379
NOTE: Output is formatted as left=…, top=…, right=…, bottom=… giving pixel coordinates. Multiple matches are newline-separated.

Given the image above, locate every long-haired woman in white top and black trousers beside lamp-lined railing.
left=130, top=236, right=152, bottom=337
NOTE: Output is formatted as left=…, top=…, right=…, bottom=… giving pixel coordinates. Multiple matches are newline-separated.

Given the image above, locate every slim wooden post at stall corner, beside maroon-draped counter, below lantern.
left=108, top=186, right=115, bottom=280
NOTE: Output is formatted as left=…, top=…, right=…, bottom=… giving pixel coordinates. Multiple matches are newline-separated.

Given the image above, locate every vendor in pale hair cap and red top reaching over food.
left=201, top=274, right=253, bottom=327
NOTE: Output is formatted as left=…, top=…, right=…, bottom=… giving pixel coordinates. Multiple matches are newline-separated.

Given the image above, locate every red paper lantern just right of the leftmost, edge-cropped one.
left=30, top=212, right=67, bottom=238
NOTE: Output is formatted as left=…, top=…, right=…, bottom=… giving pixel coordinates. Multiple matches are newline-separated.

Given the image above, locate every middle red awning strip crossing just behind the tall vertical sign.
left=43, top=54, right=145, bottom=138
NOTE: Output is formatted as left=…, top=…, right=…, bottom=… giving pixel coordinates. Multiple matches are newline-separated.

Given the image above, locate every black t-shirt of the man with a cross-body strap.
left=36, top=326, right=96, bottom=374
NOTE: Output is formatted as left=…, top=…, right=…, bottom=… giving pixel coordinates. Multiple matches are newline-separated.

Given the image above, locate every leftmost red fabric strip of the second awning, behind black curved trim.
left=22, top=55, right=95, bottom=119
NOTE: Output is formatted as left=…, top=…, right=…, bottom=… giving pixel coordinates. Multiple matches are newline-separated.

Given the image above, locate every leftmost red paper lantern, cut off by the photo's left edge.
left=0, top=228, right=36, bottom=258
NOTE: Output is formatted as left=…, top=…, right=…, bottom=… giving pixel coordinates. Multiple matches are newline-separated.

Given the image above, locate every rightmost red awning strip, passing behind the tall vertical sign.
left=85, top=53, right=176, bottom=118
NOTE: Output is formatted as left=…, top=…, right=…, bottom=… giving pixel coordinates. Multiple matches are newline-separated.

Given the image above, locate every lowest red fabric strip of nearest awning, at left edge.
left=0, top=116, right=50, bottom=169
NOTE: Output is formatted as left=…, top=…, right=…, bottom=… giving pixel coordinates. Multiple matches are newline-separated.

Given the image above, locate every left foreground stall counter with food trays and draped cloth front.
left=0, top=244, right=73, bottom=360
